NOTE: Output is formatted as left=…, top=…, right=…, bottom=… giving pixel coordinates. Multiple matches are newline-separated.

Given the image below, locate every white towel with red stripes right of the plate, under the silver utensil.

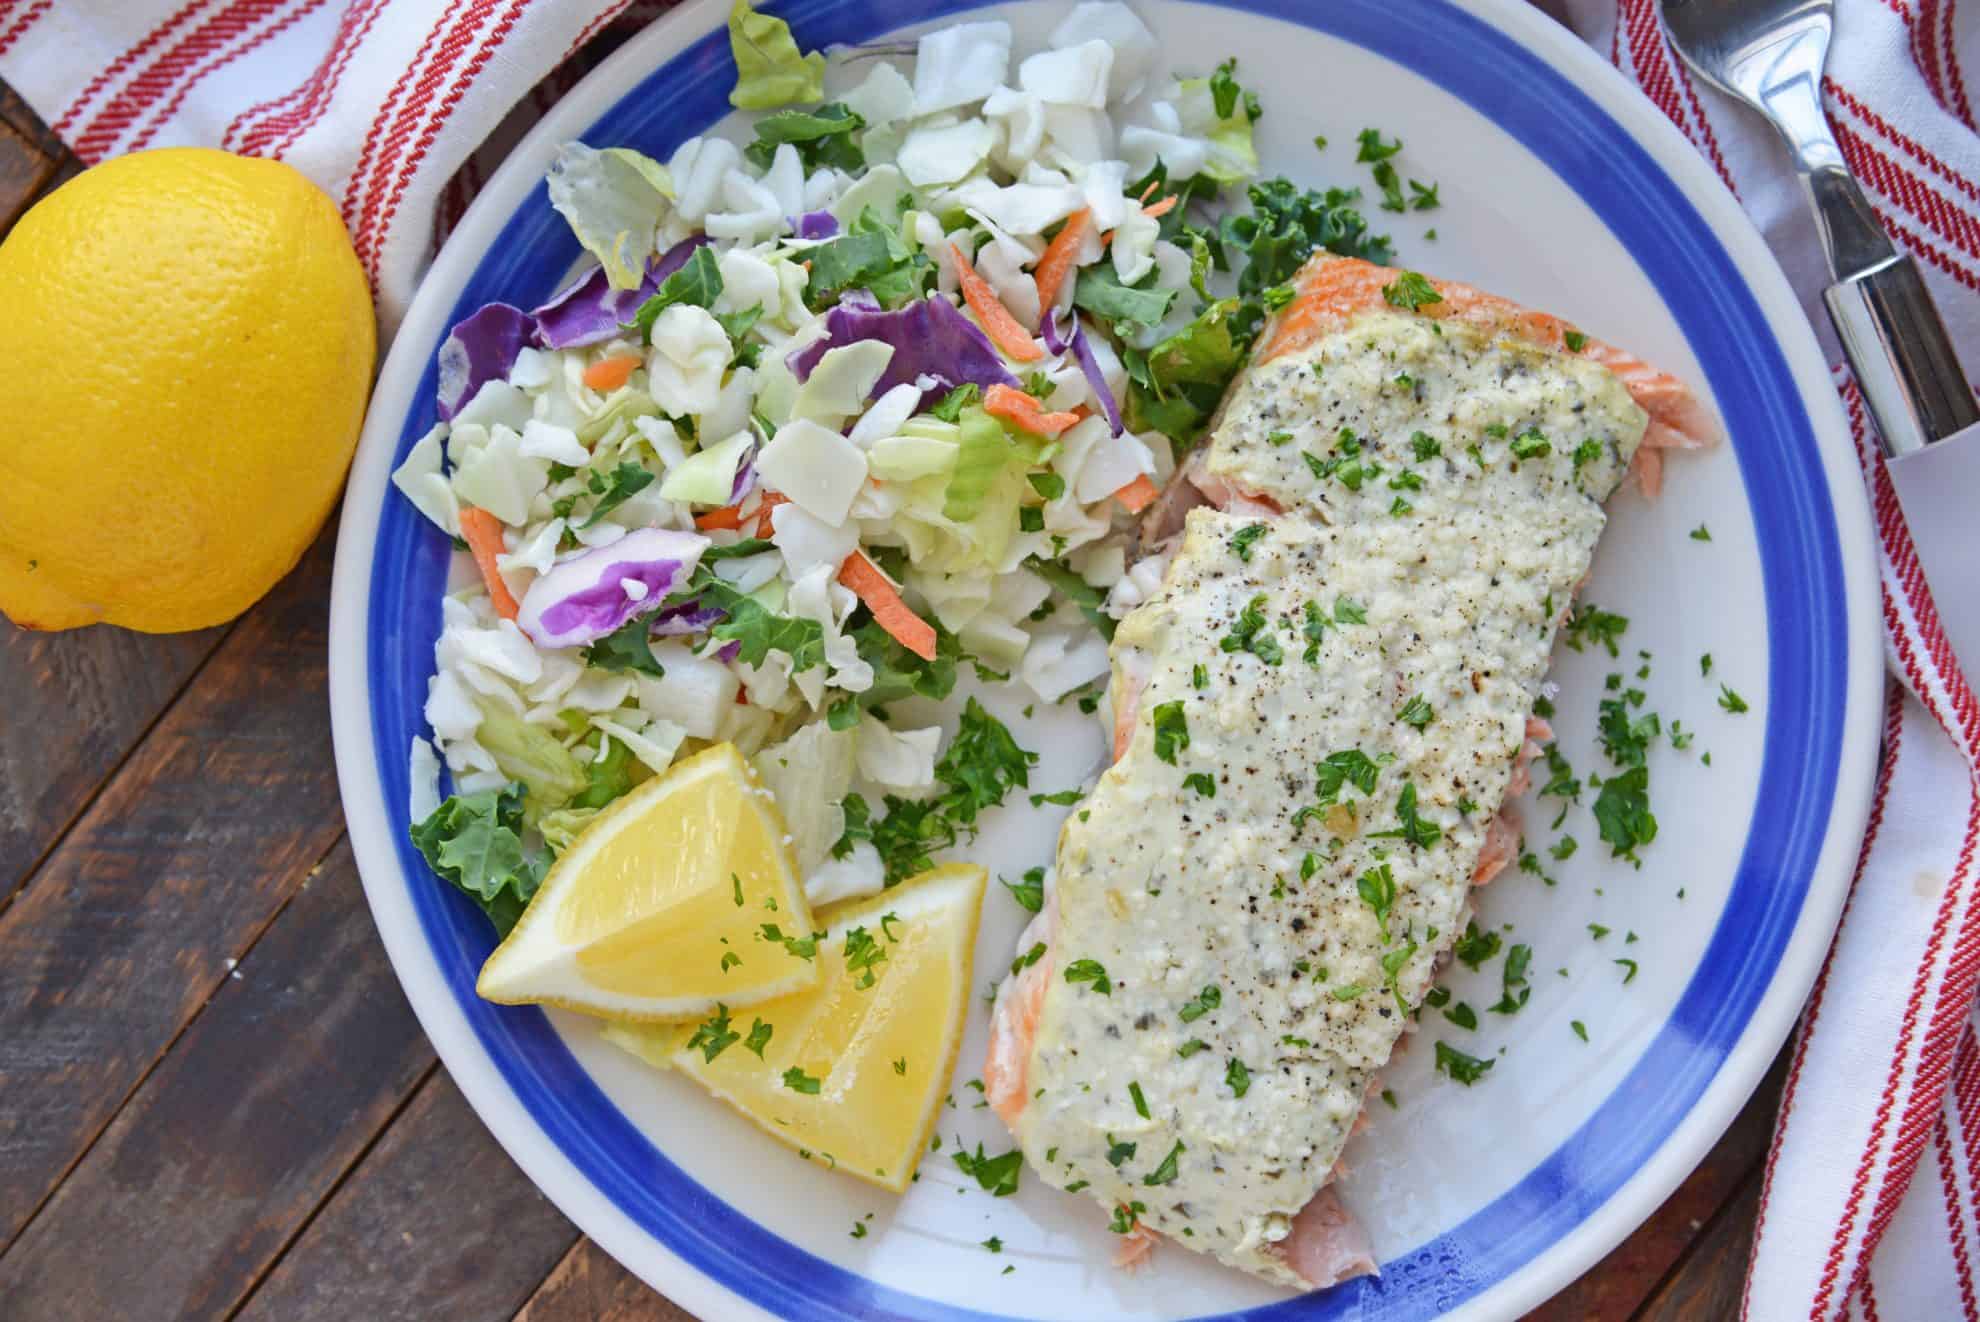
left=1566, top=0, right=1980, bottom=1322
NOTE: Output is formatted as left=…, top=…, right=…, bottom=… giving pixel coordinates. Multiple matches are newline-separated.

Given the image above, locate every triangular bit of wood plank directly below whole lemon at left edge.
left=0, top=619, right=224, bottom=906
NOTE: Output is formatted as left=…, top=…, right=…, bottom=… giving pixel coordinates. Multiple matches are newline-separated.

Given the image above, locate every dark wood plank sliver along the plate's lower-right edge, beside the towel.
left=1527, top=1047, right=1788, bottom=1322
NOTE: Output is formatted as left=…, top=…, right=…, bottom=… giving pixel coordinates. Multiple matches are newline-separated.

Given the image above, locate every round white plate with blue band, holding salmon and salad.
left=331, top=0, right=1881, bottom=1318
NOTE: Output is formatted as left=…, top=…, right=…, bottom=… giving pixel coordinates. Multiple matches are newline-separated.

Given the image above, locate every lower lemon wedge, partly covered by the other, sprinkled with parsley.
left=606, top=865, right=986, bottom=1193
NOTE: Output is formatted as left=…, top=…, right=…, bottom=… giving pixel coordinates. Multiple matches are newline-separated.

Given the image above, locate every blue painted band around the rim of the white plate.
left=364, top=0, right=1851, bottom=1322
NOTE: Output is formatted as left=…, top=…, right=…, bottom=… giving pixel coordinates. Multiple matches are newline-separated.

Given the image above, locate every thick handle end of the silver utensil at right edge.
left=1822, top=255, right=1980, bottom=459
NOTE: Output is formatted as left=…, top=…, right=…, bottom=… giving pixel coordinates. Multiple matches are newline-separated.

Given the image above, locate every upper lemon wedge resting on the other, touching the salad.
left=475, top=744, right=818, bottom=1019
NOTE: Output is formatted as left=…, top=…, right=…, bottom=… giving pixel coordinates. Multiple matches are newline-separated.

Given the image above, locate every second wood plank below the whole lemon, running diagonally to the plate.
left=0, top=536, right=343, bottom=1243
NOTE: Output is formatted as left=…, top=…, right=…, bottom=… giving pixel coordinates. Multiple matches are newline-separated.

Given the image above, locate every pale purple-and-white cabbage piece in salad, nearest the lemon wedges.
left=515, top=528, right=709, bottom=647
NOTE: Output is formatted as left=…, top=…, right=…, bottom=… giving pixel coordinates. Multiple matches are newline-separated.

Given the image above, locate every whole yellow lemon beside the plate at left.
left=0, top=148, right=376, bottom=633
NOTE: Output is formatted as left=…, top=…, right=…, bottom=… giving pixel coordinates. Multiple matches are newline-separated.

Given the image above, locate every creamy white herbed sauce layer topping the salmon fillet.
left=1000, top=311, right=1645, bottom=1284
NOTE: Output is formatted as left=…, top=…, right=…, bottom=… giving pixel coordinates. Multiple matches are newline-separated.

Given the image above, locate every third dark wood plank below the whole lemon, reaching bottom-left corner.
left=0, top=841, right=434, bottom=1322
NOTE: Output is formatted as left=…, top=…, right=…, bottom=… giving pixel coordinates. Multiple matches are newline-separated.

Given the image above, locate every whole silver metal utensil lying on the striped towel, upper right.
left=1657, top=0, right=1980, bottom=459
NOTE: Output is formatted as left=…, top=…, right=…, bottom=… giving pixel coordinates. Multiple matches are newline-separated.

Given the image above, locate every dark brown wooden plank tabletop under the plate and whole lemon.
left=0, top=87, right=1782, bottom=1322
